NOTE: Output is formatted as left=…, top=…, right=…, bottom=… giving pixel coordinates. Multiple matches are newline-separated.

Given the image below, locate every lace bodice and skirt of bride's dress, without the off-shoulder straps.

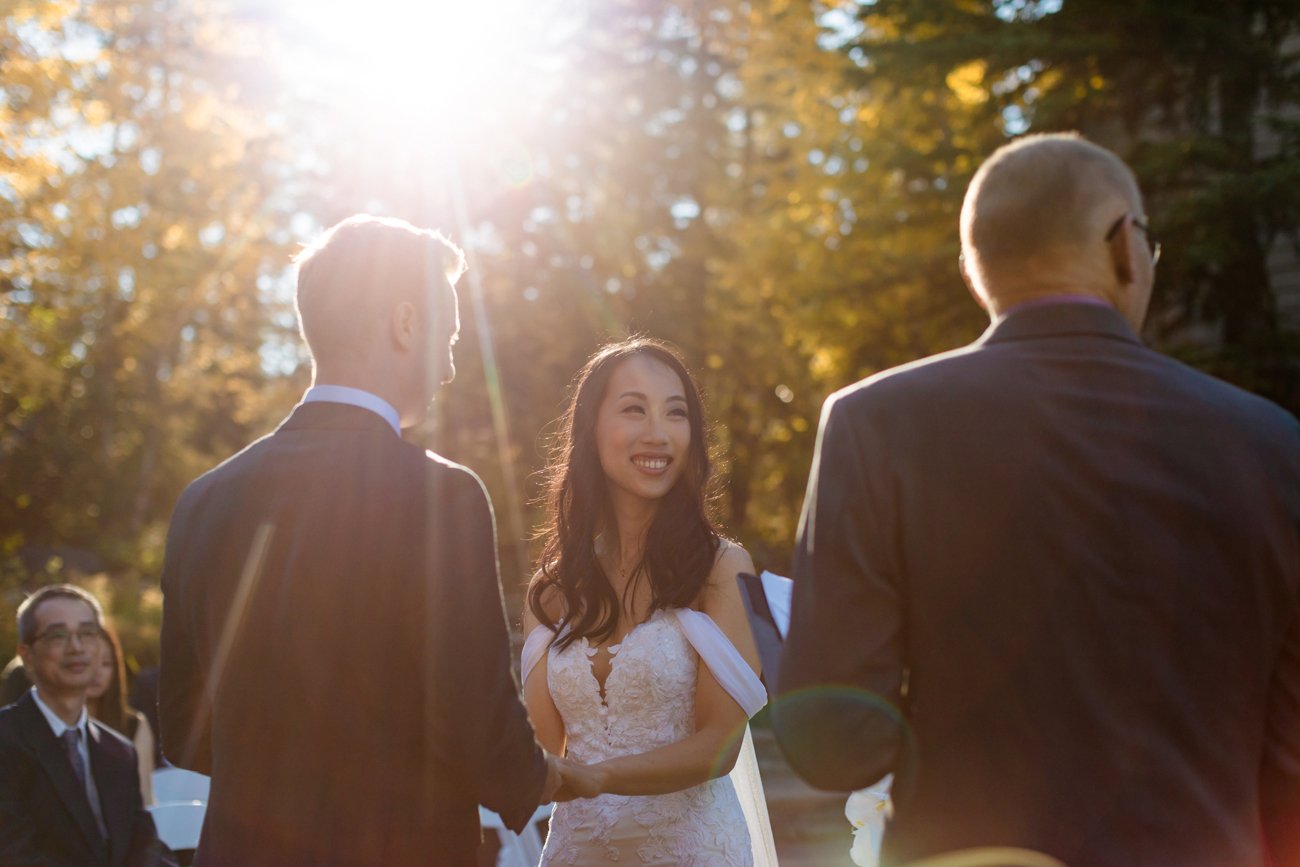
left=542, top=611, right=753, bottom=866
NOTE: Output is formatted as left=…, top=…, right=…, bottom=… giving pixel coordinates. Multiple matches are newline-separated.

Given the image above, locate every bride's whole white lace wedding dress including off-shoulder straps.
left=524, top=610, right=776, bottom=867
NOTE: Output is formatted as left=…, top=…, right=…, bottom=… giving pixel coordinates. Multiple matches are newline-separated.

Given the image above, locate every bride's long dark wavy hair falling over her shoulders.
left=528, top=338, right=720, bottom=649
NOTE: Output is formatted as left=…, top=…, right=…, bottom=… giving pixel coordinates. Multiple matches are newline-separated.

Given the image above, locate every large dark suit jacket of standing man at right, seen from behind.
left=774, top=304, right=1300, bottom=867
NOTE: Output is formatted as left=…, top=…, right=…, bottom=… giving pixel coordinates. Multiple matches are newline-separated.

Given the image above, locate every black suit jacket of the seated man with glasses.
left=0, top=693, right=174, bottom=867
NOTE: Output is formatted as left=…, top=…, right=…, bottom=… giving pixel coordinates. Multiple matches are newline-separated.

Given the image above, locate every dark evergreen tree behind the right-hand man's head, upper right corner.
left=842, top=0, right=1300, bottom=411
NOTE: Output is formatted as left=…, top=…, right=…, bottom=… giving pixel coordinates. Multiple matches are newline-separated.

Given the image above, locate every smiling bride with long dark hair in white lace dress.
left=523, top=339, right=776, bottom=866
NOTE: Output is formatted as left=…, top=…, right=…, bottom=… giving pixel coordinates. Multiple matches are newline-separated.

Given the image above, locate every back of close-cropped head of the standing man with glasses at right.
left=961, top=133, right=1149, bottom=323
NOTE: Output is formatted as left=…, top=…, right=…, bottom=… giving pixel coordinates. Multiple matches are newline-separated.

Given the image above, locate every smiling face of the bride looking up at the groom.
left=595, top=355, right=693, bottom=509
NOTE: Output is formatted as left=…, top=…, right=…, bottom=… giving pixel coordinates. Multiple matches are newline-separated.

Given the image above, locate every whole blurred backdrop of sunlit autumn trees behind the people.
left=0, top=0, right=1300, bottom=655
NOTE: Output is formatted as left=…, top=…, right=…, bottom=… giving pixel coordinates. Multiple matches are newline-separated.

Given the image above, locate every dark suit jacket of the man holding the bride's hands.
left=160, top=403, right=546, bottom=867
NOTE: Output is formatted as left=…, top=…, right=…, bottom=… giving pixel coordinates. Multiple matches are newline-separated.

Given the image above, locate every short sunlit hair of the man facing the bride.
left=294, top=214, right=465, bottom=359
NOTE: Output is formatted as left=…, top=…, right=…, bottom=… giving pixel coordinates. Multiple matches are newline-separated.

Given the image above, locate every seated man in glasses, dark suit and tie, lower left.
left=0, top=584, right=176, bottom=867
